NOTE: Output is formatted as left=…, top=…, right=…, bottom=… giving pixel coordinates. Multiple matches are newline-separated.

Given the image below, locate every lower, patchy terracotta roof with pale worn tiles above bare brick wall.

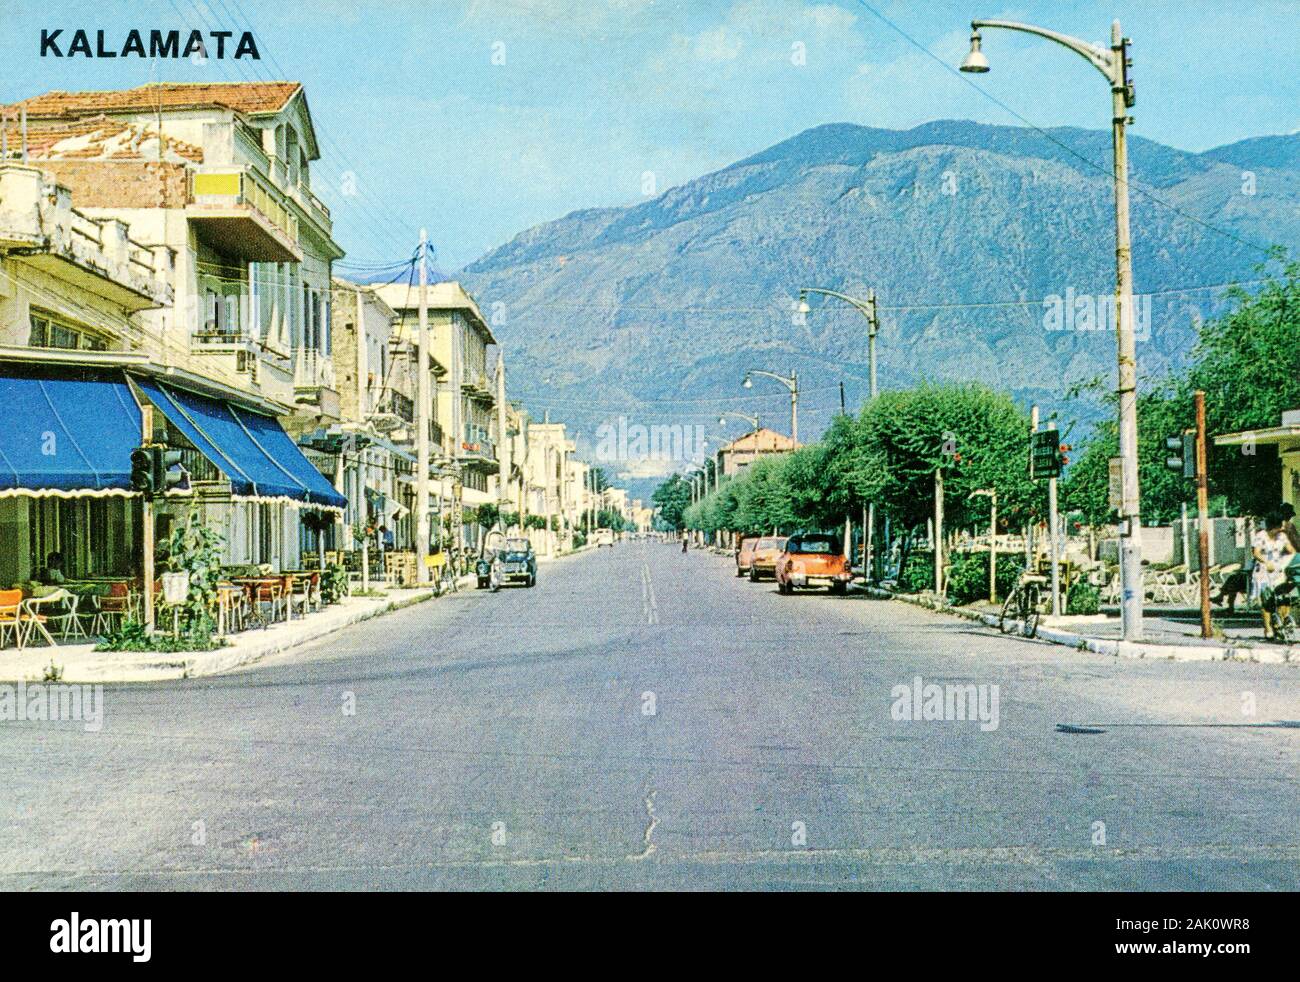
left=4, top=113, right=203, bottom=164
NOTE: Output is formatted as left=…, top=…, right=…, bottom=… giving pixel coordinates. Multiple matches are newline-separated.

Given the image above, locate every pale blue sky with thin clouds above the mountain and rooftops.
left=0, top=0, right=1300, bottom=271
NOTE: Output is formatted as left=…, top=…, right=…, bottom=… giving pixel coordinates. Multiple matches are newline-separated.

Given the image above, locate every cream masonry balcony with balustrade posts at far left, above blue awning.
left=0, top=164, right=172, bottom=312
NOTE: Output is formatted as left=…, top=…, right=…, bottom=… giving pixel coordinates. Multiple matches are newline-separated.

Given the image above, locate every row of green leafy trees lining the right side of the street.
left=653, top=251, right=1300, bottom=533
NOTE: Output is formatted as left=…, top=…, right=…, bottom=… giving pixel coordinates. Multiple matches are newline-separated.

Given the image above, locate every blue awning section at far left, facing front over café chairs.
left=0, top=365, right=140, bottom=497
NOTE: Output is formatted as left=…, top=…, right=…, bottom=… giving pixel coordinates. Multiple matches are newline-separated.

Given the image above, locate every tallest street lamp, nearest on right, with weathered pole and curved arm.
left=962, top=21, right=1143, bottom=641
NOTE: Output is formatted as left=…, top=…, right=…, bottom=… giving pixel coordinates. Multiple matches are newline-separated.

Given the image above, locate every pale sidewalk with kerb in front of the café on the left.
left=0, top=576, right=441, bottom=683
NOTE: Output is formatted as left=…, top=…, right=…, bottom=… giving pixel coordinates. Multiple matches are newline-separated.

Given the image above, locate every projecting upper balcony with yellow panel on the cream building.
left=186, top=166, right=303, bottom=263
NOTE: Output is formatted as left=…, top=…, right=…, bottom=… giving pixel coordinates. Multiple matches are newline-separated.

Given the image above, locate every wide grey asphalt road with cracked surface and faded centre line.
left=0, top=542, right=1300, bottom=890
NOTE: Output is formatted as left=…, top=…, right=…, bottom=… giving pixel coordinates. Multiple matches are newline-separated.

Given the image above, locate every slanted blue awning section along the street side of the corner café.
left=138, top=378, right=347, bottom=509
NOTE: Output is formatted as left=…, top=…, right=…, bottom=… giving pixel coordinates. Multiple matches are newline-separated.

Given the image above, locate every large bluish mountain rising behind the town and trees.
left=459, top=121, right=1300, bottom=494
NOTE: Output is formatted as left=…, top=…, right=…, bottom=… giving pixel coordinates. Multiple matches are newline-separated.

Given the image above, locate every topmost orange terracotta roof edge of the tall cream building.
left=5, top=82, right=302, bottom=118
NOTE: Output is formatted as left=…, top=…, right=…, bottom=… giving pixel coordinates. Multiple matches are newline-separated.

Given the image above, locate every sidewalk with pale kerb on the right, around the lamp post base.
left=863, top=587, right=1300, bottom=665
